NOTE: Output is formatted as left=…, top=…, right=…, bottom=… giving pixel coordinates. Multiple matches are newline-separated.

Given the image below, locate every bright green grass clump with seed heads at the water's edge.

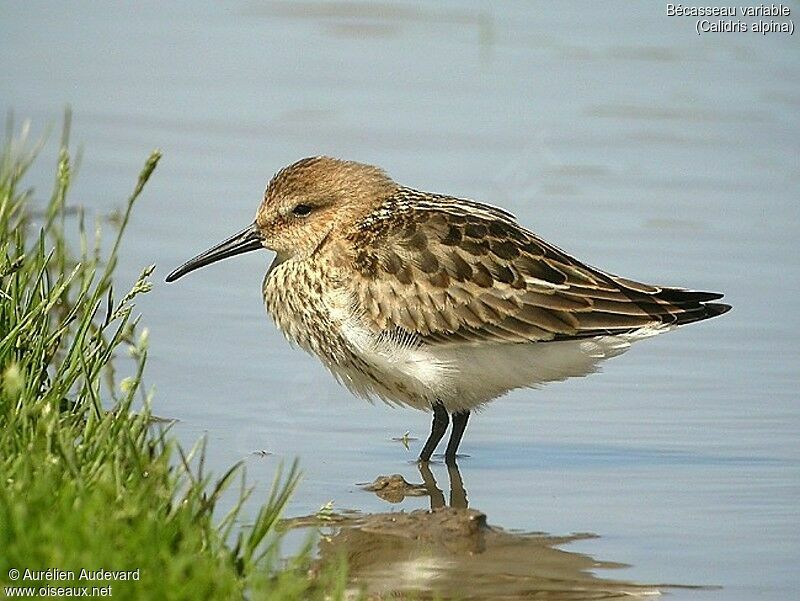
left=0, top=119, right=344, bottom=599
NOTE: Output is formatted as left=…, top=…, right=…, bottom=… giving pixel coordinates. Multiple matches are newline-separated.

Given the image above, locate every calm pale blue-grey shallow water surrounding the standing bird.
left=0, top=2, right=800, bottom=600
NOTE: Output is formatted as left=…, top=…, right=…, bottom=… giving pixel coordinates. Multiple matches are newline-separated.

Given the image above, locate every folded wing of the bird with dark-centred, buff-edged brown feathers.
left=352, top=189, right=728, bottom=344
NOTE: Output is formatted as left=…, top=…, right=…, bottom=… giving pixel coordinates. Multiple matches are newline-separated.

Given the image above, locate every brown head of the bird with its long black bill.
left=167, top=156, right=398, bottom=282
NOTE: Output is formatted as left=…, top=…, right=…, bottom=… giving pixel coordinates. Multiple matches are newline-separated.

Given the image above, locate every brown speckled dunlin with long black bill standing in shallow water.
left=167, top=157, right=730, bottom=463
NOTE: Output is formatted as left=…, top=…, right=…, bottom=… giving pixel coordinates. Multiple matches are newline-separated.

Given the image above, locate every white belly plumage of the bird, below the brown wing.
left=331, top=304, right=666, bottom=412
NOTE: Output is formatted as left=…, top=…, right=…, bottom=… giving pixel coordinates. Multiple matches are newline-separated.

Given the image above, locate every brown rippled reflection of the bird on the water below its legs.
left=282, top=464, right=692, bottom=601
